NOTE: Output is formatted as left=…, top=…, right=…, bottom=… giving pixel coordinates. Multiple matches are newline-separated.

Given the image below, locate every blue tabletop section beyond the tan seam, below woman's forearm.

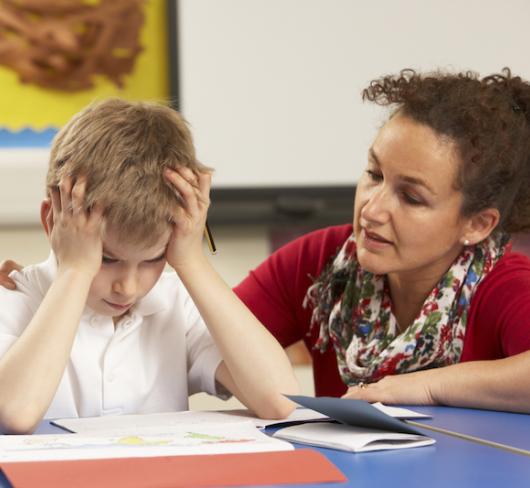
left=400, top=405, right=530, bottom=452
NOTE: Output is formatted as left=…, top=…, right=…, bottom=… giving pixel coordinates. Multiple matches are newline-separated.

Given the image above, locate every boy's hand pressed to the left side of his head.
left=47, top=177, right=103, bottom=275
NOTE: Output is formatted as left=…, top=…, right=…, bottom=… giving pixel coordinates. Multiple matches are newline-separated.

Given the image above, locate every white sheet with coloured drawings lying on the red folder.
left=0, top=421, right=293, bottom=462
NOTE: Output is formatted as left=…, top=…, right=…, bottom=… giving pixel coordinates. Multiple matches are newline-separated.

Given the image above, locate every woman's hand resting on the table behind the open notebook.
left=342, top=370, right=438, bottom=405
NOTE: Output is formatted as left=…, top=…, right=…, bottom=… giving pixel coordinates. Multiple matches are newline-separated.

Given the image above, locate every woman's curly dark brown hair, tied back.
left=363, top=68, right=530, bottom=233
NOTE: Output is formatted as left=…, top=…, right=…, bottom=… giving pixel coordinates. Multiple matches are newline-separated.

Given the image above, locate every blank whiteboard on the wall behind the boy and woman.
left=178, top=0, right=530, bottom=188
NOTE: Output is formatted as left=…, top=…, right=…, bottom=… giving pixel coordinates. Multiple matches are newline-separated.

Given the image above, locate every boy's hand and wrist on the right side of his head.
left=164, top=167, right=212, bottom=268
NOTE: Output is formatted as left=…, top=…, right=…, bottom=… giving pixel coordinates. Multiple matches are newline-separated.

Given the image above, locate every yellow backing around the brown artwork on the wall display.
left=0, top=0, right=170, bottom=132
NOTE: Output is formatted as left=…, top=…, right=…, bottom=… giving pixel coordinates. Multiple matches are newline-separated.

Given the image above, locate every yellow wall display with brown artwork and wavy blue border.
left=0, top=0, right=169, bottom=147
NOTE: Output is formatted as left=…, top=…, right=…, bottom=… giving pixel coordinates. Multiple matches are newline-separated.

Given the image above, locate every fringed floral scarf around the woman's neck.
left=304, top=233, right=508, bottom=386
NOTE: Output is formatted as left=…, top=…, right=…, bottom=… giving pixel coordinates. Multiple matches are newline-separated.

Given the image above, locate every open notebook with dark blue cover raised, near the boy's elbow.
left=273, top=395, right=435, bottom=452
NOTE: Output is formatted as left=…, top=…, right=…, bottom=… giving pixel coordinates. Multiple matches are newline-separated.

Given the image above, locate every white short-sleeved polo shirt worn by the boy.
left=0, top=253, right=225, bottom=418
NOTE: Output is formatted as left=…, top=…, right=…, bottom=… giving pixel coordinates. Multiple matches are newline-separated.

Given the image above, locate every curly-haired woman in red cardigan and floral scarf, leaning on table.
left=1, top=69, right=530, bottom=412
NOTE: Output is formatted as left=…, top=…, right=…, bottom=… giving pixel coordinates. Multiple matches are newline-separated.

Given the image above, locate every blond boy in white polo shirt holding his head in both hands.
left=0, top=100, right=297, bottom=433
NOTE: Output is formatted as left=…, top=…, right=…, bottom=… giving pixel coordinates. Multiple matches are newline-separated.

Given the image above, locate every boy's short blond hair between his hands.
left=46, top=99, right=207, bottom=246
